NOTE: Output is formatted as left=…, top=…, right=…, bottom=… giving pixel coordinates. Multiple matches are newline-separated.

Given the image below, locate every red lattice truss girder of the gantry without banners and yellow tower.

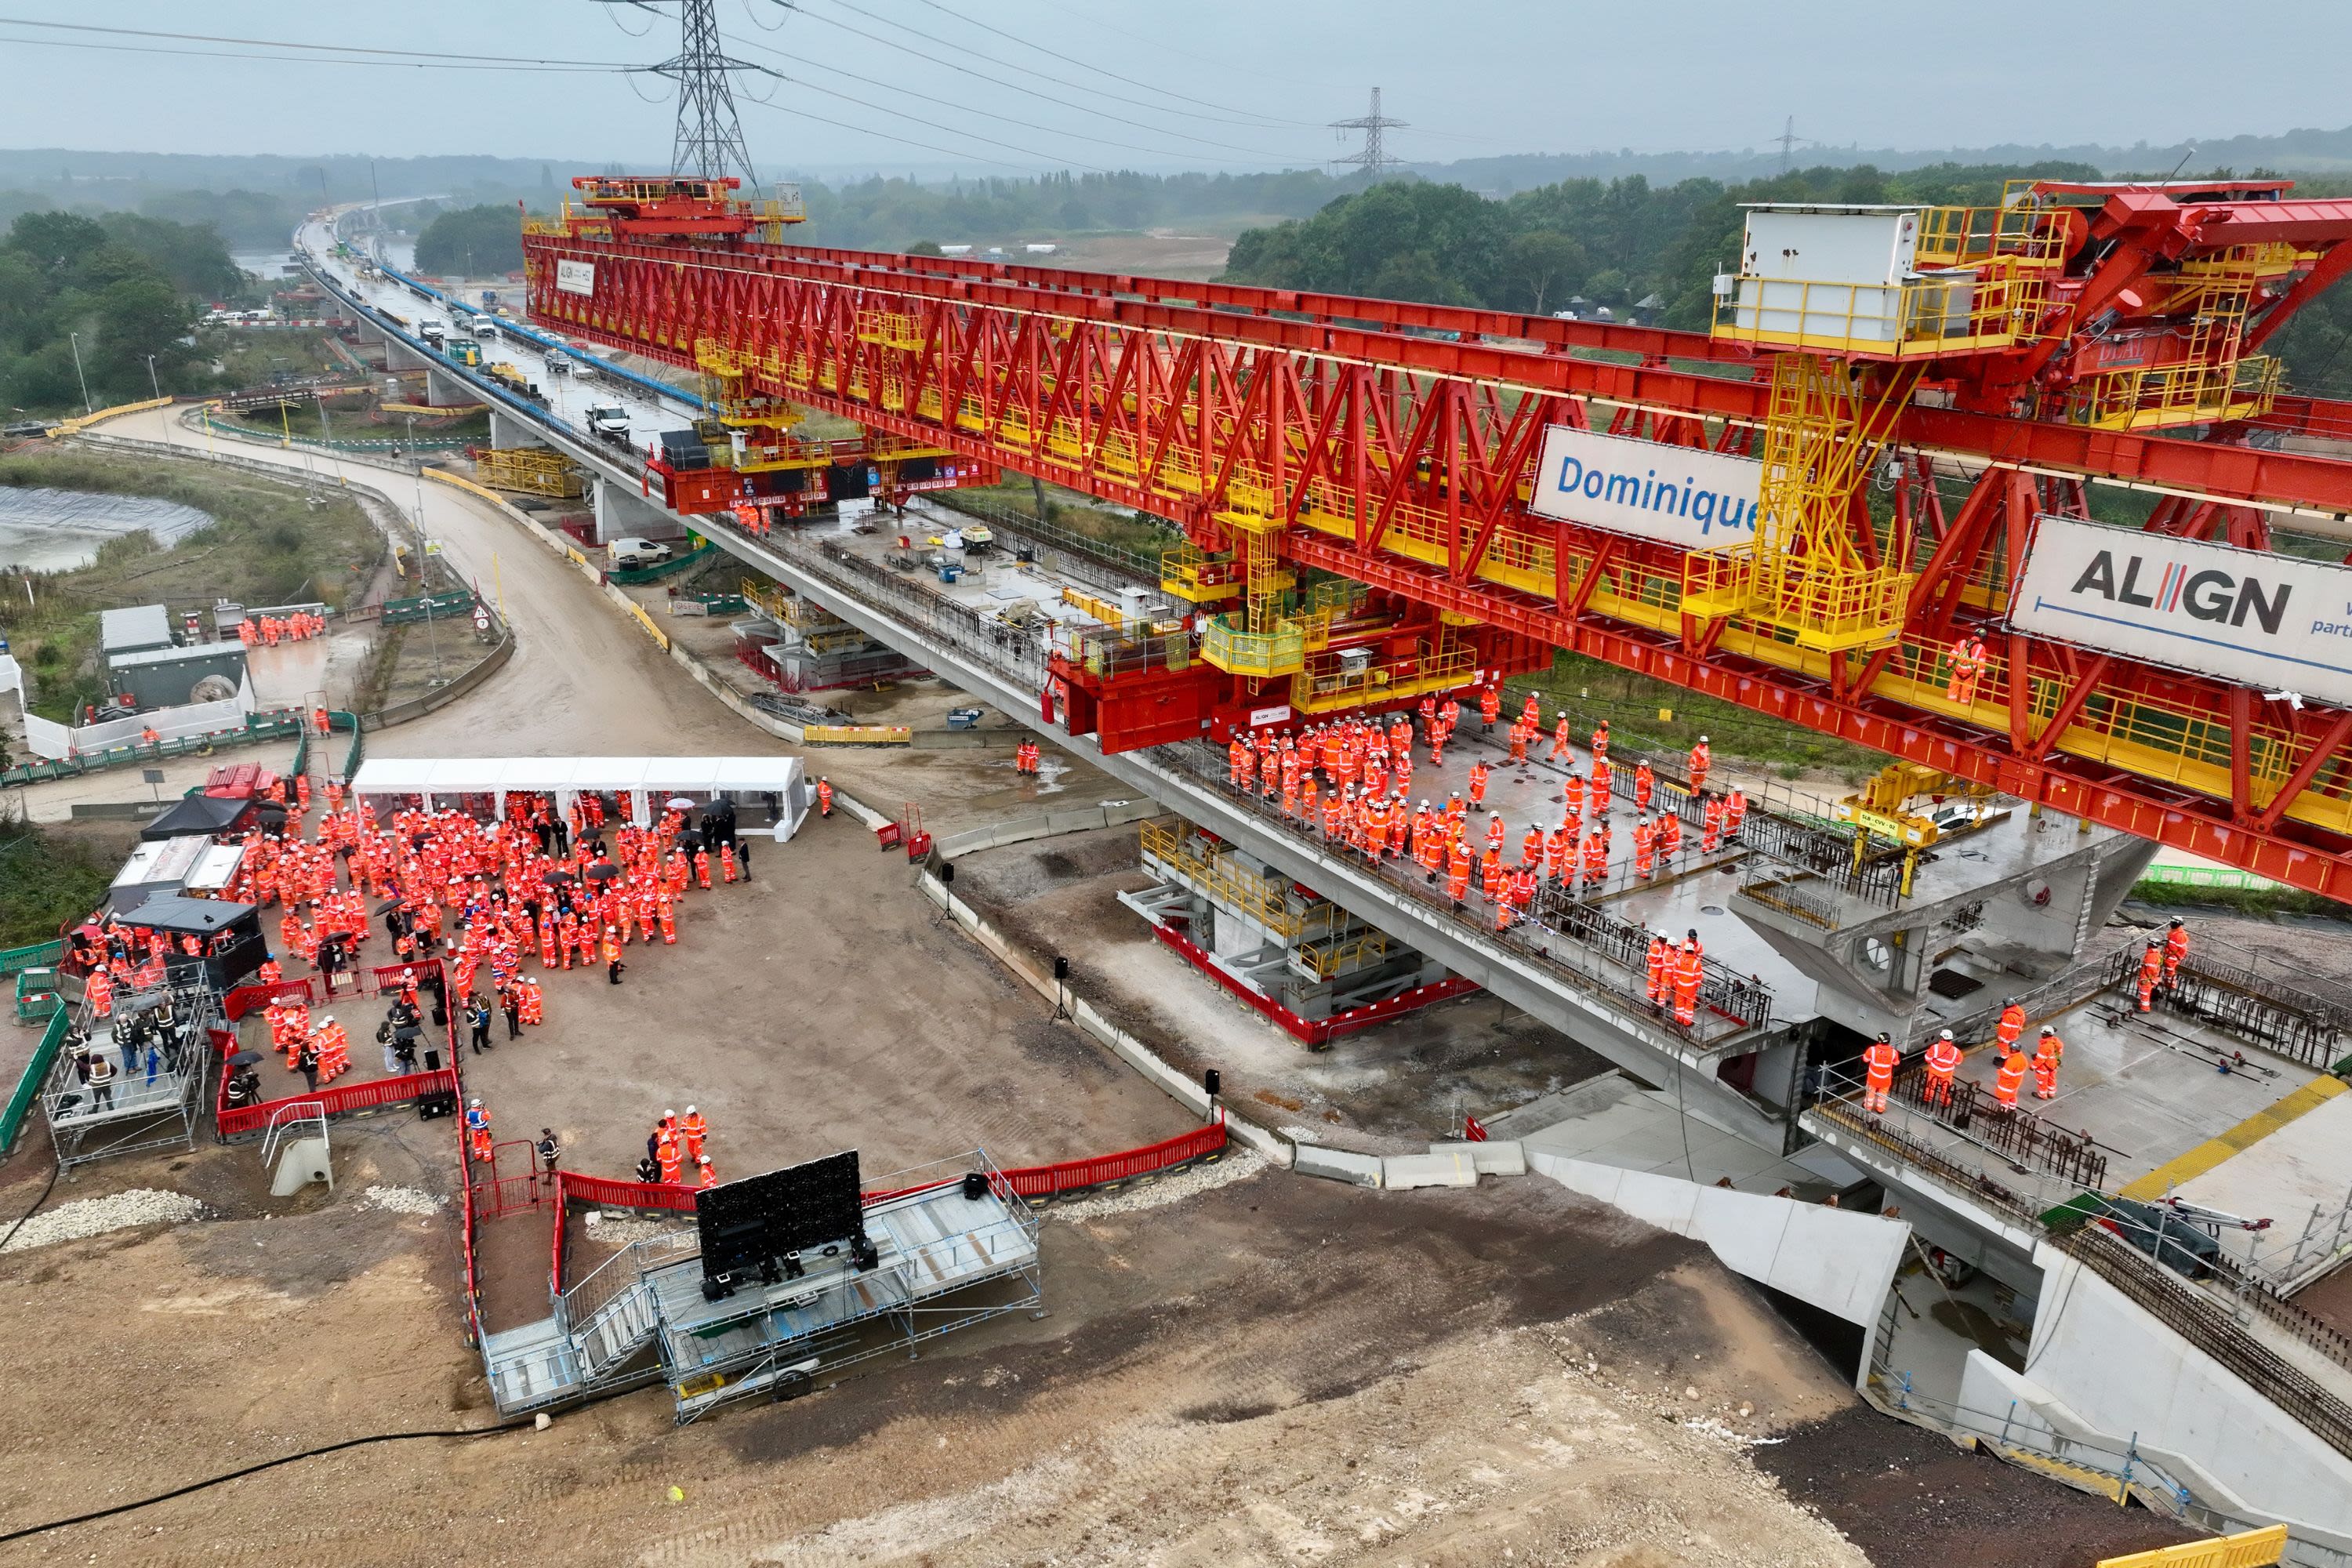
left=524, top=188, right=2352, bottom=898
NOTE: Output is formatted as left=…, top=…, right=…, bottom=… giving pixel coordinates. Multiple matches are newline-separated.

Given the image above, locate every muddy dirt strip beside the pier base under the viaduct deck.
left=955, top=827, right=1609, bottom=1149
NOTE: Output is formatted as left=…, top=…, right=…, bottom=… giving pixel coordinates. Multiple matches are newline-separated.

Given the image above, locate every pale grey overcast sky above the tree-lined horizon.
left=0, top=0, right=2352, bottom=172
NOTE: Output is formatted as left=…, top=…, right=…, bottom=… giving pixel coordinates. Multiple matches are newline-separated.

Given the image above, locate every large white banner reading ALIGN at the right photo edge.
left=2009, top=517, right=2352, bottom=706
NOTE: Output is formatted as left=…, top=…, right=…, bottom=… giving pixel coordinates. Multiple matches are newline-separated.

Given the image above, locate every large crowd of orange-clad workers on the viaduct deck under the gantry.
left=1225, top=687, right=1748, bottom=931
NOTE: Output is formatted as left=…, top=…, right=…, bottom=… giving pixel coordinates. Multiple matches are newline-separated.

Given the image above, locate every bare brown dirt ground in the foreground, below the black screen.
left=0, top=1147, right=2192, bottom=1568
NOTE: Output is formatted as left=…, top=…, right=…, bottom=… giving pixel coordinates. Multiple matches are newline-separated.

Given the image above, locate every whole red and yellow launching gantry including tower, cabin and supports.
left=524, top=181, right=2352, bottom=898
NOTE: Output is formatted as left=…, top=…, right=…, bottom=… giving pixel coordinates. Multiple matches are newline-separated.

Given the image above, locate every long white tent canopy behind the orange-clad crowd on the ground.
left=350, top=757, right=811, bottom=841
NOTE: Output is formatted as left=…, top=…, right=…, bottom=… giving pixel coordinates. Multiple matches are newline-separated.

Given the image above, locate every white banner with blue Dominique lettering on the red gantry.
left=1526, top=426, right=1764, bottom=550
